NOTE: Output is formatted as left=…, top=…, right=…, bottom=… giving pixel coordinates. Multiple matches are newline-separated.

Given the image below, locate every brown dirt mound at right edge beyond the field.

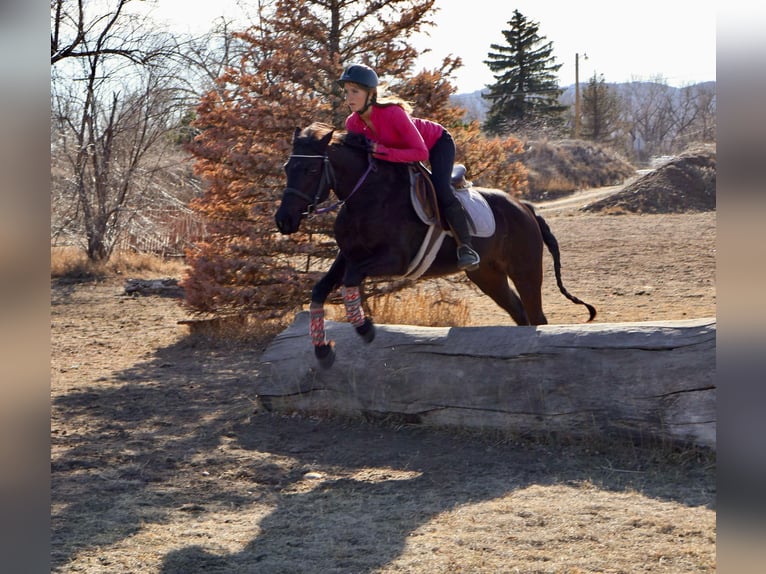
left=582, top=146, right=716, bottom=214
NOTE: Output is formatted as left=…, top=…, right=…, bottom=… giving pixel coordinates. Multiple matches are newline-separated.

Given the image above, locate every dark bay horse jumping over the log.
left=275, top=123, right=596, bottom=367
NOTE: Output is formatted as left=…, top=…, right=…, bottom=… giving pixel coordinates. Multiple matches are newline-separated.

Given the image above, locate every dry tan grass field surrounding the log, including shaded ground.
left=51, top=199, right=716, bottom=574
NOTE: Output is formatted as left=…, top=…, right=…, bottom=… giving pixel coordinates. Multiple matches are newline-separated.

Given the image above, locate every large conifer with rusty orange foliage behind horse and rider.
left=183, top=0, right=518, bottom=318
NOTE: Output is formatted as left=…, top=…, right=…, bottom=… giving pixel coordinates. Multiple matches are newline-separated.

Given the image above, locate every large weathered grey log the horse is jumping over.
left=257, top=312, right=716, bottom=448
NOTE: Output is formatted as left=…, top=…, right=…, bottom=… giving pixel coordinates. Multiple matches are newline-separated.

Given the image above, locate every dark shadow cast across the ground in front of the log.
left=52, top=337, right=715, bottom=574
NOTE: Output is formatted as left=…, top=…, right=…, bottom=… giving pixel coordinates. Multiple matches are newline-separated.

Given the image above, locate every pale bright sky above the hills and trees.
left=146, top=0, right=719, bottom=93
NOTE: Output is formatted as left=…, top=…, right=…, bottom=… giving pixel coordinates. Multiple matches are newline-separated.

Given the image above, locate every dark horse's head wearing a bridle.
left=275, top=123, right=333, bottom=235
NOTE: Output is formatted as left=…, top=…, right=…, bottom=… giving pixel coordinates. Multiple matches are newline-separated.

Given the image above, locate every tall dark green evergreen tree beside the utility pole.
left=483, top=10, right=566, bottom=135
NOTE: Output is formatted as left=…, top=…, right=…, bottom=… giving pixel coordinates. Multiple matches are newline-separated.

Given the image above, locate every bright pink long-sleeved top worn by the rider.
left=346, top=105, right=444, bottom=163
